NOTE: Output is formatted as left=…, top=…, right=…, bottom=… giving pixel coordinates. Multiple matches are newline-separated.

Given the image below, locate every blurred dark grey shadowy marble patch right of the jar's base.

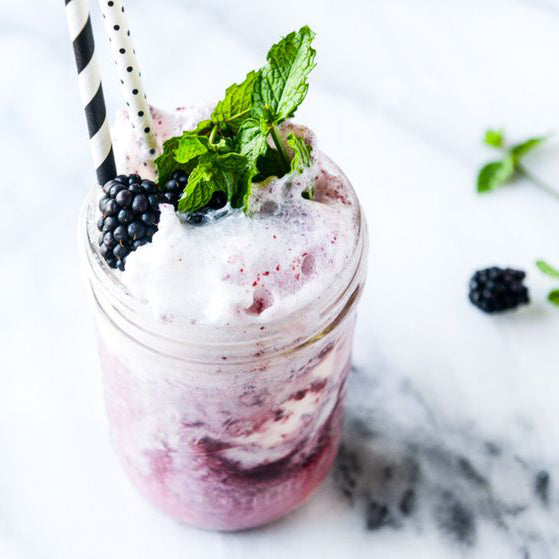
left=334, top=370, right=559, bottom=559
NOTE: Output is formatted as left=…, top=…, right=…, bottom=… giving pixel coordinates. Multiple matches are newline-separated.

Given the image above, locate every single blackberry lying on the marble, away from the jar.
left=469, top=266, right=530, bottom=313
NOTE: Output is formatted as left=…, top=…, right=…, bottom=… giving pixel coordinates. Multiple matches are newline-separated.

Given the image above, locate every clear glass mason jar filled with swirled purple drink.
left=79, top=160, right=368, bottom=530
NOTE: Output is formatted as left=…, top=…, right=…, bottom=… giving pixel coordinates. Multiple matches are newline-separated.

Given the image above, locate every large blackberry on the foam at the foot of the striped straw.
left=97, top=175, right=164, bottom=270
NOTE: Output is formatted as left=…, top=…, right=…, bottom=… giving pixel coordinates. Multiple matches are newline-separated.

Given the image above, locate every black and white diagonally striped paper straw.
left=64, top=0, right=116, bottom=185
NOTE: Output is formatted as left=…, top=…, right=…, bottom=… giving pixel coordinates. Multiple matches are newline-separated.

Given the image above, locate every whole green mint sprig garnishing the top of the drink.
left=155, top=26, right=316, bottom=212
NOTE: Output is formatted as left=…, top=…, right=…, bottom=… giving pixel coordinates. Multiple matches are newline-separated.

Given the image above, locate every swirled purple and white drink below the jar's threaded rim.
left=99, top=317, right=353, bottom=530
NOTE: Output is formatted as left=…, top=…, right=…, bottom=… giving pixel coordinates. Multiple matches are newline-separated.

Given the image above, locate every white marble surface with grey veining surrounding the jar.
left=0, top=0, right=559, bottom=559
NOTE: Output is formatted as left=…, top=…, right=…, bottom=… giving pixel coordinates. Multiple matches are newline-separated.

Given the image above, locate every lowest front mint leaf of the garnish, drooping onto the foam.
left=178, top=153, right=247, bottom=213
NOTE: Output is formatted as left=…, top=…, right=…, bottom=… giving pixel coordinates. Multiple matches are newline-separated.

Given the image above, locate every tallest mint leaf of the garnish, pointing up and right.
left=252, top=26, right=316, bottom=127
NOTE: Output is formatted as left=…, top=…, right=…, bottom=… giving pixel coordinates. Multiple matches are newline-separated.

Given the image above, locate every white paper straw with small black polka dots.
left=99, top=0, right=157, bottom=159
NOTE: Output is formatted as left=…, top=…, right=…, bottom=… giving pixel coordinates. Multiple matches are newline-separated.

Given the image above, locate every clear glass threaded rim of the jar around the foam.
left=78, top=154, right=368, bottom=359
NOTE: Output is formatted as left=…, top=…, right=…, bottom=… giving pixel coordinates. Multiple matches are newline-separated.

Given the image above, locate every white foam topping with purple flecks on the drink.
left=113, top=108, right=357, bottom=324
